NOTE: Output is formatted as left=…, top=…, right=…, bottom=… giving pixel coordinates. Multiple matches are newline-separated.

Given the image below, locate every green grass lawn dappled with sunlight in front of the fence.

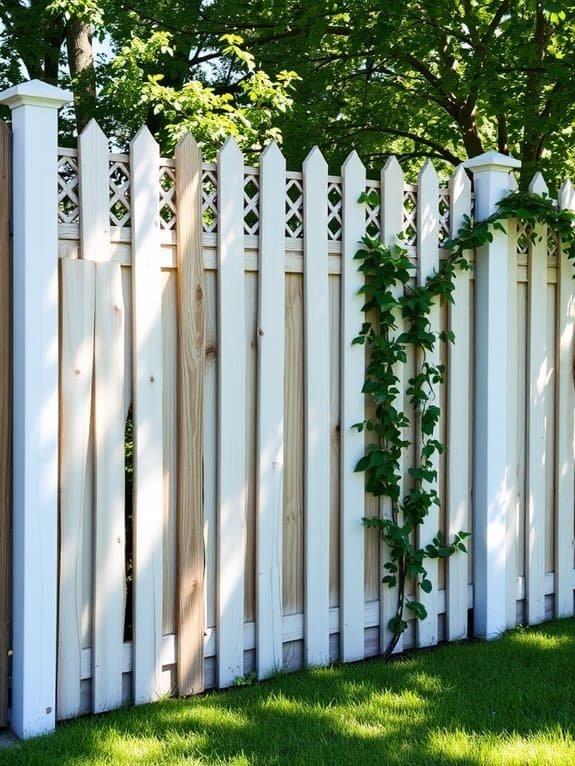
left=0, top=620, right=575, bottom=766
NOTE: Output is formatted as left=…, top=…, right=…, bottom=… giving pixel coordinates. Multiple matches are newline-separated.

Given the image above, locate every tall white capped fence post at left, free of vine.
left=0, top=80, right=72, bottom=738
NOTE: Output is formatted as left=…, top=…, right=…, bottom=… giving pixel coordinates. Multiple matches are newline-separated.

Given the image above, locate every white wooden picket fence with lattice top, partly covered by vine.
left=5, top=84, right=575, bottom=736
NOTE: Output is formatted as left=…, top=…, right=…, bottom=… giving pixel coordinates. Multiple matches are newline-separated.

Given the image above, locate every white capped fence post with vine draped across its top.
left=465, top=152, right=521, bottom=638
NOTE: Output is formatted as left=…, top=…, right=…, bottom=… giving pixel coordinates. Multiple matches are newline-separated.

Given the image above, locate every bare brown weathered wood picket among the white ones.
left=176, top=134, right=207, bottom=695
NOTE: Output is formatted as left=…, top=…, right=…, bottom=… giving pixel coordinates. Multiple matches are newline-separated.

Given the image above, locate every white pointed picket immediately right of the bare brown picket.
left=217, top=138, right=246, bottom=687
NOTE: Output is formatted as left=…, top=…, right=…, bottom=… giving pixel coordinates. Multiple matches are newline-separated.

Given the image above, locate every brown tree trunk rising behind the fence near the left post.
left=66, top=18, right=96, bottom=134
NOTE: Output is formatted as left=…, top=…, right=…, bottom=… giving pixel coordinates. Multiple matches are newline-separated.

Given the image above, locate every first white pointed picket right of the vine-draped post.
left=525, top=173, right=549, bottom=625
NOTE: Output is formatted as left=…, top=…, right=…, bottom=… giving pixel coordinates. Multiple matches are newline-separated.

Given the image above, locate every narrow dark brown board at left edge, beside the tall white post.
left=0, top=120, right=12, bottom=727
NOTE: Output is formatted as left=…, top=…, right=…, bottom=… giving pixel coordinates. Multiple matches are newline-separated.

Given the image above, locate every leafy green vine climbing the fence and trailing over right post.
left=353, top=192, right=575, bottom=658
